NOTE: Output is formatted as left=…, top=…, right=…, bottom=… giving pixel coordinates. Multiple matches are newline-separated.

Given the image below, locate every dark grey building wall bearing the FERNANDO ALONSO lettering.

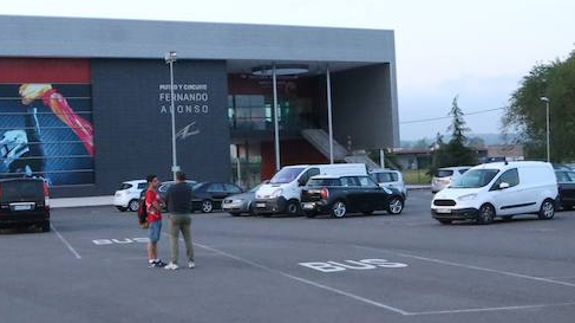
left=52, top=59, right=231, bottom=197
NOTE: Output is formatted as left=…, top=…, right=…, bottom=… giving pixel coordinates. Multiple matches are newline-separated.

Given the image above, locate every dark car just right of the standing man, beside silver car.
left=192, top=182, right=242, bottom=213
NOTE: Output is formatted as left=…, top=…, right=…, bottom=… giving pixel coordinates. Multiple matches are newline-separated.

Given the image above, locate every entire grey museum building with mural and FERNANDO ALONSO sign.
left=0, top=16, right=399, bottom=196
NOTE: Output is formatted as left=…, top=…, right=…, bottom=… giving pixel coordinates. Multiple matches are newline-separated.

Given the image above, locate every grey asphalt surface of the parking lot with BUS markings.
left=0, top=191, right=575, bottom=323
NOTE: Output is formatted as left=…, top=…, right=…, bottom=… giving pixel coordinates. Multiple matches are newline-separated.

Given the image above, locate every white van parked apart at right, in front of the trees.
left=431, top=162, right=558, bottom=224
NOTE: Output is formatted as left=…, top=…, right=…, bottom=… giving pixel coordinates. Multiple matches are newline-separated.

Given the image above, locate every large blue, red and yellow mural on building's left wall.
left=0, top=58, right=94, bottom=186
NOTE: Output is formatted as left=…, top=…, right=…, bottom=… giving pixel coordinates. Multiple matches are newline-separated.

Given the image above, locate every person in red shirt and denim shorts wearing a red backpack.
left=145, top=175, right=166, bottom=268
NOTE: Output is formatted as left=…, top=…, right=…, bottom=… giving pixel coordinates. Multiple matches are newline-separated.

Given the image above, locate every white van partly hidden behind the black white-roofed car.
left=253, top=164, right=367, bottom=215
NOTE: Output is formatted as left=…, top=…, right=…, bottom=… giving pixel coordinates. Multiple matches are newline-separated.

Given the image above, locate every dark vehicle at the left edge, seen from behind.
left=0, top=178, right=50, bottom=232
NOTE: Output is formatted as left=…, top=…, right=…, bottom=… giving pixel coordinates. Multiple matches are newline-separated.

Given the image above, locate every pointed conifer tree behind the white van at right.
left=430, top=96, right=477, bottom=172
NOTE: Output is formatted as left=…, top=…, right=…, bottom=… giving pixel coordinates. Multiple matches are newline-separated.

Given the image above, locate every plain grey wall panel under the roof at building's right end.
left=326, top=64, right=399, bottom=149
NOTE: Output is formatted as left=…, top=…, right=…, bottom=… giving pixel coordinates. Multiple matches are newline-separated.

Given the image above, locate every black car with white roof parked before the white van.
left=301, top=176, right=404, bottom=218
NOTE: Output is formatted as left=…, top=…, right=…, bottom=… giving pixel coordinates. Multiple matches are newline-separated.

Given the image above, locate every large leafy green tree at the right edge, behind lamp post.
left=502, top=51, right=575, bottom=162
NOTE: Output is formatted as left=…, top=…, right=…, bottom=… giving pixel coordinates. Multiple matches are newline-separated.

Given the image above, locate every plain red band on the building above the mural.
left=0, top=58, right=91, bottom=84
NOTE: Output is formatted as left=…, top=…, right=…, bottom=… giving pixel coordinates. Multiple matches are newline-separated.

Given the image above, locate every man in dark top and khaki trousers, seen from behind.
left=164, top=172, right=195, bottom=270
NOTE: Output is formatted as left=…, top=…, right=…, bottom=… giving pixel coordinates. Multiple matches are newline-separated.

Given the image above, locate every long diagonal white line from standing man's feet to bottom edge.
left=194, top=243, right=410, bottom=315
